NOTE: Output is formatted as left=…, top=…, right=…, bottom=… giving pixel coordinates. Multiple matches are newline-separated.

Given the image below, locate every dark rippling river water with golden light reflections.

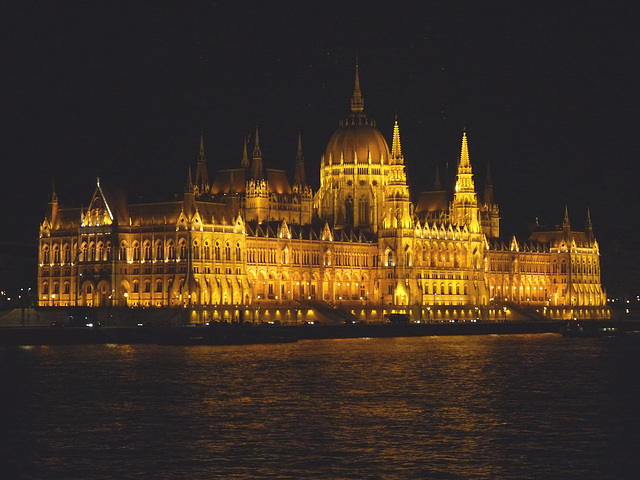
left=0, top=334, right=640, bottom=479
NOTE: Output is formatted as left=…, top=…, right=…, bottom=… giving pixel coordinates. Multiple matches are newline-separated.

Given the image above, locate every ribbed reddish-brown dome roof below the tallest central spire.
left=324, top=114, right=389, bottom=165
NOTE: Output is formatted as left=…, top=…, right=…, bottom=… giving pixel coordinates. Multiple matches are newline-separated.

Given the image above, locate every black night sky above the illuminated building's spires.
left=0, top=1, right=640, bottom=248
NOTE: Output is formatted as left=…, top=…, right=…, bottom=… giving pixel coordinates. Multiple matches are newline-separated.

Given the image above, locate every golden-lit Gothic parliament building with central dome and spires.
left=38, top=66, right=609, bottom=323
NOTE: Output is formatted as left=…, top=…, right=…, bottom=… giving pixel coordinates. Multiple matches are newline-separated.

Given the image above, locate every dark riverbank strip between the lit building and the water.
left=0, top=321, right=640, bottom=346
